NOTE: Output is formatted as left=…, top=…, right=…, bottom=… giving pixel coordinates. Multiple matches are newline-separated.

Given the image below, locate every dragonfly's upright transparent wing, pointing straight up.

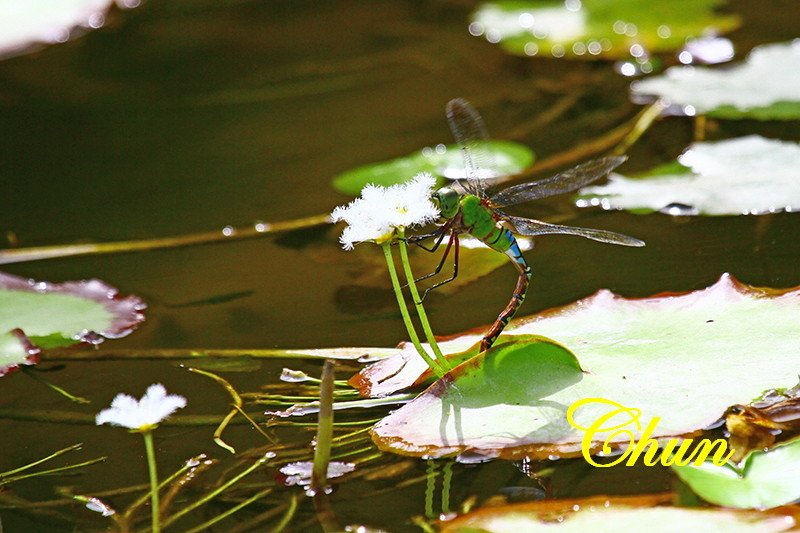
left=446, top=98, right=494, bottom=198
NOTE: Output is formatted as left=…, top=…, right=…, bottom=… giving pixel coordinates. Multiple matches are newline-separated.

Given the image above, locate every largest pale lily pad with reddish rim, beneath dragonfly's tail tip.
left=370, top=274, right=800, bottom=459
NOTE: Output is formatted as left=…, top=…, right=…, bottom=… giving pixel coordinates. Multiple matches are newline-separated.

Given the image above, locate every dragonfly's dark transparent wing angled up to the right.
left=491, top=156, right=628, bottom=207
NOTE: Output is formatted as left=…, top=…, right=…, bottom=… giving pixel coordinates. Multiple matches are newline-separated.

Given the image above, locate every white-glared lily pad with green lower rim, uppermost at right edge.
left=631, top=40, right=800, bottom=120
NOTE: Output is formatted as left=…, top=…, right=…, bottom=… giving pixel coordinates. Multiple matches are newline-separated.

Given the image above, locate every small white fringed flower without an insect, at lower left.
left=95, top=383, right=186, bottom=431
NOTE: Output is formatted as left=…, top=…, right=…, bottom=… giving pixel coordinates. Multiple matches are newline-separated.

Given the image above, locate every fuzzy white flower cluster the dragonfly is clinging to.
left=331, top=172, right=439, bottom=250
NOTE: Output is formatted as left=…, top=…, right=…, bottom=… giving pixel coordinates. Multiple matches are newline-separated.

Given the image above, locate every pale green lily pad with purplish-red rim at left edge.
left=0, top=272, right=146, bottom=375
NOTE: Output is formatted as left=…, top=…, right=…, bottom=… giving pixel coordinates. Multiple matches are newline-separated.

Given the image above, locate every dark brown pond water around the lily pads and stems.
left=0, top=0, right=800, bottom=532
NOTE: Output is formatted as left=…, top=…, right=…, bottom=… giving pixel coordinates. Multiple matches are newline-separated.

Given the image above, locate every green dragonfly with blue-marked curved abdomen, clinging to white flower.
left=410, top=98, right=645, bottom=352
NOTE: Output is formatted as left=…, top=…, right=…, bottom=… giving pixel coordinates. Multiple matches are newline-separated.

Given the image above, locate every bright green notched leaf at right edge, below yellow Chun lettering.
left=672, top=439, right=800, bottom=509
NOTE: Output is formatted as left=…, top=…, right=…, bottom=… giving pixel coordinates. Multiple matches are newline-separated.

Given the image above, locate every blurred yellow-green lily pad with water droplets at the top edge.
left=470, top=0, right=740, bottom=59
